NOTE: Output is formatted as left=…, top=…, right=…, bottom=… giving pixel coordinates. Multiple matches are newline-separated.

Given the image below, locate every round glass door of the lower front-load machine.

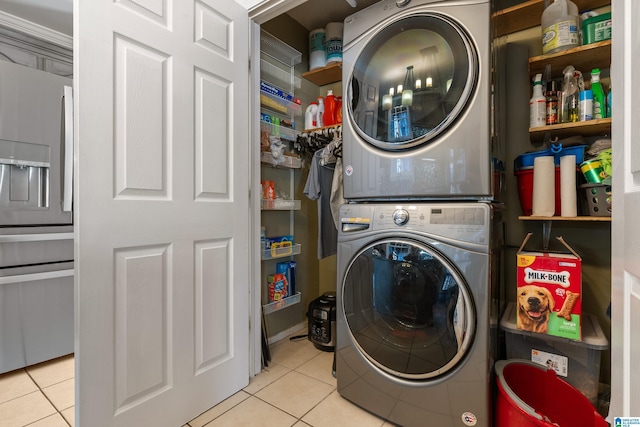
left=342, top=238, right=476, bottom=380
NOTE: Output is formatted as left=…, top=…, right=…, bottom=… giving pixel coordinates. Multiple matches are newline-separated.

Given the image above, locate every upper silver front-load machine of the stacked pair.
left=342, top=0, right=502, bottom=201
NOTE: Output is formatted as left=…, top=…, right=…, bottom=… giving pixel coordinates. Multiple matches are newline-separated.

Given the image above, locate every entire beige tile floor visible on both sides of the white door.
left=0, top=331, right=392, bottom=427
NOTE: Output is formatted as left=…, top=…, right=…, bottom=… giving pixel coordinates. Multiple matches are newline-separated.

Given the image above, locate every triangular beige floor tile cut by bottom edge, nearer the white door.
left=207, top=396, right=297, bottom=427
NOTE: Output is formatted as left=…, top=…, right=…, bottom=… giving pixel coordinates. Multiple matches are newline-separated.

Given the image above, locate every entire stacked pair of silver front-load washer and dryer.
left=335, top=0, right=502, bottom=427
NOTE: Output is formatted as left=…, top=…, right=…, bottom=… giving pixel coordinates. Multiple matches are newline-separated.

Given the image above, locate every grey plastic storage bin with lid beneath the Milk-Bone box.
left=500, top=303, right=609, bottom=406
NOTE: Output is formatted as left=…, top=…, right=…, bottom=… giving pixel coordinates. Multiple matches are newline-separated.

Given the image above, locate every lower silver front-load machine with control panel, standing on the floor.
left=336, top=202, right=500, bottom=427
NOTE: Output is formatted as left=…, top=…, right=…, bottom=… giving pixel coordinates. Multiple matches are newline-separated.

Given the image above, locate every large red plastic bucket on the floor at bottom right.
left=495, top=359, right=608, bottom=427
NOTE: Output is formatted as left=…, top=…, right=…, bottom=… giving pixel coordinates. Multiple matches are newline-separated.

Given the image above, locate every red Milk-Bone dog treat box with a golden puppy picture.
left=516, top=233, right=582, bottom=341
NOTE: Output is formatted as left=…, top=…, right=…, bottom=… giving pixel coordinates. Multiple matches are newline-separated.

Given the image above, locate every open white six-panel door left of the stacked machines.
left=74, top=0, right=250, bottom=427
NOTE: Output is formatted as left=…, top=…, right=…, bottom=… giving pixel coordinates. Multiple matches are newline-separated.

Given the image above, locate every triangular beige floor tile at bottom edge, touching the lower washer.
left=302, top=391, right=384, bottom=427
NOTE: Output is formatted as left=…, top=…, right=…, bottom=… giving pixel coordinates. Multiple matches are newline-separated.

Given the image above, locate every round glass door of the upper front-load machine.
left=346, top=13, right=479, bottom=151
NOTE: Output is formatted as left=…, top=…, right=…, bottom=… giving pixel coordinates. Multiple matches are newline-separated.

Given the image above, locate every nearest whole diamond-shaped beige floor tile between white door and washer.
left=255, top=371, right=334, bottom=418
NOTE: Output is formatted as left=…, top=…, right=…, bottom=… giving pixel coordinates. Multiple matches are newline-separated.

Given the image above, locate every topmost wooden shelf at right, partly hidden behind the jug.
left=492, top=0, right=611, bottom=37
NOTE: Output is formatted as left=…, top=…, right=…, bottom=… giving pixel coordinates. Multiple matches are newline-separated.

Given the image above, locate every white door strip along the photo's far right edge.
left=608, top=0, right=640, bottom=418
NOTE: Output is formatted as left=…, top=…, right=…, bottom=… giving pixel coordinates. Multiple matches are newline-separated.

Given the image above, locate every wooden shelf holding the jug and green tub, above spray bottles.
left=529, top=40, right=611, bottom=76
